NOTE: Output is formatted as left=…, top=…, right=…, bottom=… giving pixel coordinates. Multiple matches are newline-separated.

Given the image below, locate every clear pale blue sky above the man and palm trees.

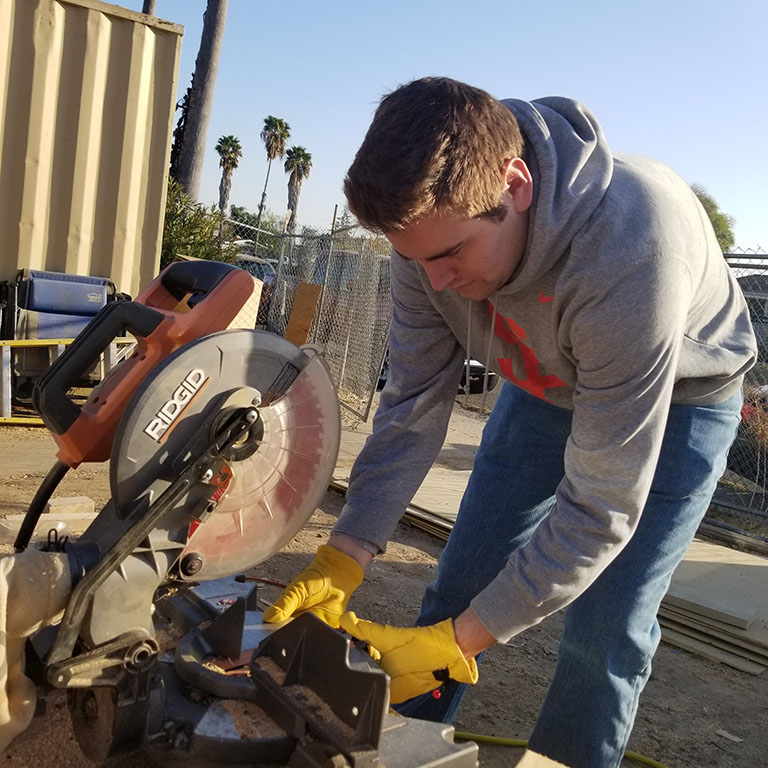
left=153, top=0, right=768, bottom=252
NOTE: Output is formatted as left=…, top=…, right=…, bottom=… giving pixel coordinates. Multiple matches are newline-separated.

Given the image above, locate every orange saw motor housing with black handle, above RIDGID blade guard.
left=33, top=261, right=256, bottom=468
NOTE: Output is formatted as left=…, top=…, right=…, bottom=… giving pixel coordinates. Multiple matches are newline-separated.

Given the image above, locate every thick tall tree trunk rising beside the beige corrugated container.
left=178, top=0, right=229, bottom=201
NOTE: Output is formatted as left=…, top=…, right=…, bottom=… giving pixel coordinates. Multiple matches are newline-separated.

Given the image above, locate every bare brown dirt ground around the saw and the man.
left=0, top=408, right=768, bottom=768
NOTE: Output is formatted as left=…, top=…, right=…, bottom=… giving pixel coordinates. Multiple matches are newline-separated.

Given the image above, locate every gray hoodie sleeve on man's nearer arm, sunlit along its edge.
left=472, top=257, right=692, bottom=642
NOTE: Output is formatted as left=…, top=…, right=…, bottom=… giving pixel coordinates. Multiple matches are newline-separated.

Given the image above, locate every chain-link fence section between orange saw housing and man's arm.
left=222, top=220, right=392, bottom=421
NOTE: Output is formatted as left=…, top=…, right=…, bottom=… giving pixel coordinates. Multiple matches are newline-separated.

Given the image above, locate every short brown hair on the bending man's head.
left=344, top=77, right=523, bottom=232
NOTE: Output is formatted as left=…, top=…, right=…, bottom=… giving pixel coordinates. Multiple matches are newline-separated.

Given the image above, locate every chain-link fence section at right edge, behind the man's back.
left=715, top=248, right=768, bottom=518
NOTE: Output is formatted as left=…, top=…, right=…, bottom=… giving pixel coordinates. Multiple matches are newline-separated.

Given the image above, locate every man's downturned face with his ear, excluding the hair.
left=387, top=161, right=532, bottom=301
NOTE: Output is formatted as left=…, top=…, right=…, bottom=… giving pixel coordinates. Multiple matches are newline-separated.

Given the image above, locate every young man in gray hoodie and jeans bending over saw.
left=265, top=78, right=756, bottom=768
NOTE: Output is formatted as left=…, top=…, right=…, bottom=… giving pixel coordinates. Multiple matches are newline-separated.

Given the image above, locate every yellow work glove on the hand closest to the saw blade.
left=264, top=544, right=363, bottom=627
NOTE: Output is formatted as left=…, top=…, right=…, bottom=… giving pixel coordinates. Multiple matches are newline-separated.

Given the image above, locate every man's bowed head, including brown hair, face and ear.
left=344, top=78, right=533, bottom=301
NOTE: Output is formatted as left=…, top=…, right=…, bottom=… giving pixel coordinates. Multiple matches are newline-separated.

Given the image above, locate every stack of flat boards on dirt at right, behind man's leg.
left=659, top=539, right=768, bottom=675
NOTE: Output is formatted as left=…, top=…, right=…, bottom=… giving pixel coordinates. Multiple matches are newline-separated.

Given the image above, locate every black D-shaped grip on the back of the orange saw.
left=32, top=301, right=164, bottom=435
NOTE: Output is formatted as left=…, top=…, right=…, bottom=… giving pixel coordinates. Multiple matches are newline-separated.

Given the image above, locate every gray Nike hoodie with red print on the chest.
left=334, top=98, right=757, bottom=642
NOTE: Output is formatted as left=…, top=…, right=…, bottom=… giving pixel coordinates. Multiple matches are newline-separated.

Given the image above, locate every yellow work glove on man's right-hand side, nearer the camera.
left=339, top=611, right=477, bottom=704
